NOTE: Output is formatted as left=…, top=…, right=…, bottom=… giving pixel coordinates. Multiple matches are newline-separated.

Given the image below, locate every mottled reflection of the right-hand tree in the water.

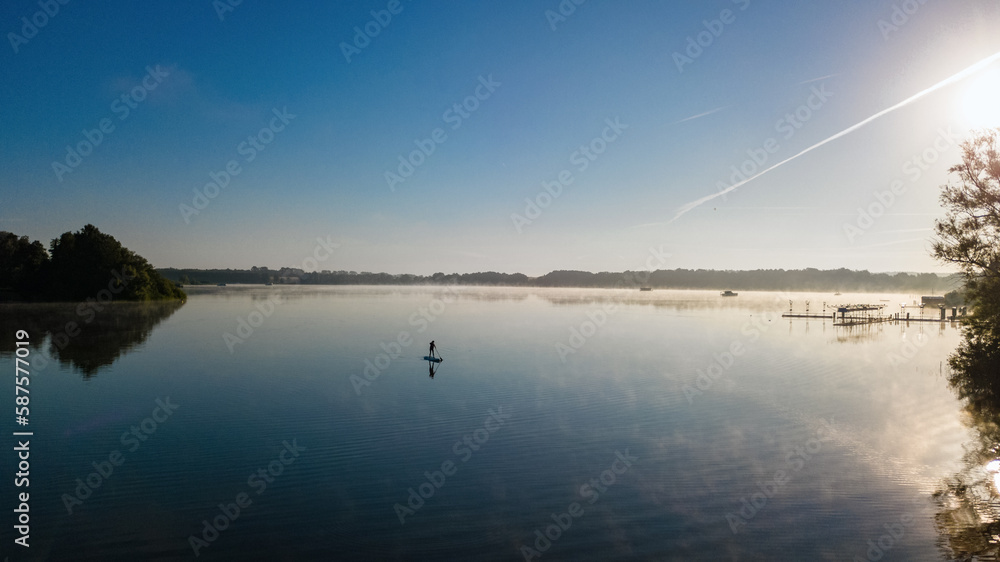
left=935, top=357, right=1000, bottom=560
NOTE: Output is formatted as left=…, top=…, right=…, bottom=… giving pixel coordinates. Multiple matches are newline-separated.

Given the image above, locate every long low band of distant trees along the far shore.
left=152, top=267, right=959, bottom=294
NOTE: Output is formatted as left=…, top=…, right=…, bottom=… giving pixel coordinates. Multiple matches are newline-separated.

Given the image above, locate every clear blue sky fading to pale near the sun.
left=0, top=0, right=1000, bottom=275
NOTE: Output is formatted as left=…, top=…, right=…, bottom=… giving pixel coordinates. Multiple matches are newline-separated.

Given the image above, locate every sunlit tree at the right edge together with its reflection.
left=933, top=129, right=1000, bottom=560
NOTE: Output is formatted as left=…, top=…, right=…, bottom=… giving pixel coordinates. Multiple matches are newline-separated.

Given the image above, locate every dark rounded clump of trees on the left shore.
left=0, top=224, right=185, bottom=302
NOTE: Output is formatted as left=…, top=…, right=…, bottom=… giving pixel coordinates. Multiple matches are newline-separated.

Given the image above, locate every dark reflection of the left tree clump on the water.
left=0, top=301, right=184, bottom=379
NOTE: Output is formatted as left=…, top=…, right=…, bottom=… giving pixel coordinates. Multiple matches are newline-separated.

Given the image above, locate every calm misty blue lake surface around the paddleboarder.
left=0, top=286, right=977, bottom=560
